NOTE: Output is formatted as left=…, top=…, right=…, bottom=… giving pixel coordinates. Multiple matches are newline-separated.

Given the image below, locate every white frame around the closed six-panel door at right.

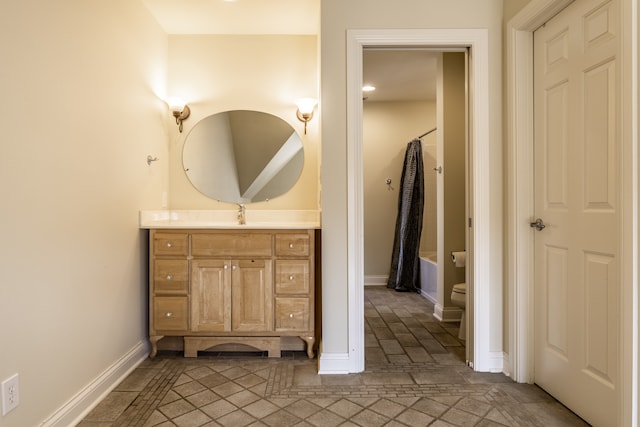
left=505, top=0, right=640, bottom=425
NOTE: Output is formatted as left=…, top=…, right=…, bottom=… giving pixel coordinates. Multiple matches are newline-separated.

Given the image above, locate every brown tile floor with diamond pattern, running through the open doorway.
left=79, top=287, right=587, bottom=427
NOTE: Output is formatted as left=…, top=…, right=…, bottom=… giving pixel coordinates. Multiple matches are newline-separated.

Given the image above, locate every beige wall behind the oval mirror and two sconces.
left=168, top=35, right=321, bottom=210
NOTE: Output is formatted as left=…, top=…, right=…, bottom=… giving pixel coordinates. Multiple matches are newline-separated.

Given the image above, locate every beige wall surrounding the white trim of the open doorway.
left=320, top=0, right=503, bottom=355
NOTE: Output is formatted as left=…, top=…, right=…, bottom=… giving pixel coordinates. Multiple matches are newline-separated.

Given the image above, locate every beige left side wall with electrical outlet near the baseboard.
left=0, top=0, right=168, bottom=427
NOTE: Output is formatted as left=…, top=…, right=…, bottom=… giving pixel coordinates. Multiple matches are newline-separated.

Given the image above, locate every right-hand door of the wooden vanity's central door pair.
left=231, top=259, right=273, bottom=332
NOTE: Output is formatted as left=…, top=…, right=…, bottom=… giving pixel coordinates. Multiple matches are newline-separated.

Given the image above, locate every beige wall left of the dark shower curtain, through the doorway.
left=362, top=102, right=436, bottom=284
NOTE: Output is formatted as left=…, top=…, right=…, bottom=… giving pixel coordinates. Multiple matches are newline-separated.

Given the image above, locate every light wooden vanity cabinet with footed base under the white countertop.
left=149, top=229, right=315, bottom=358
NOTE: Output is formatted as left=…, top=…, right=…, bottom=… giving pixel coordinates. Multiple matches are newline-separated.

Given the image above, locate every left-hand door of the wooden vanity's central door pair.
left=191, top=259, right=231, bottom=332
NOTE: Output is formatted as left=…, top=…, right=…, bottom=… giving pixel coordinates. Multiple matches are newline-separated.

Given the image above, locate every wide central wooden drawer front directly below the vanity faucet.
left=191, top=233, right=272, bottom=257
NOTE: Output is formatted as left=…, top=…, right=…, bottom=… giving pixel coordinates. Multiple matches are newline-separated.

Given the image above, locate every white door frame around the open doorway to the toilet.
left=347, top=29, right=504, bottom=372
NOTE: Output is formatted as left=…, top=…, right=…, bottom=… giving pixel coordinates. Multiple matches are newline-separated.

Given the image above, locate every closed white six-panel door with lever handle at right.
left=532, top=0, right=621, bottom=426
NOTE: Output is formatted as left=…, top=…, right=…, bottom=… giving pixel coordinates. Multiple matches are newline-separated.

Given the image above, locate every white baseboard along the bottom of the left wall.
left=40, top=341, right=149, bottom=427
